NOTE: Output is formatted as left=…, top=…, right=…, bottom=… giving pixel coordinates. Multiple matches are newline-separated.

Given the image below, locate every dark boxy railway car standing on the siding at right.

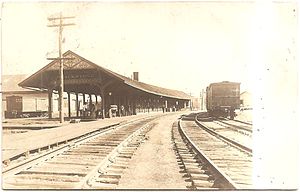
left=206, top=81, right=240, bottom=119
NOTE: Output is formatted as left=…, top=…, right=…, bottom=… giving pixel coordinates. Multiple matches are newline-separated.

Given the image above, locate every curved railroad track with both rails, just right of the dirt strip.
left=173, top=114, right=252, bottom=189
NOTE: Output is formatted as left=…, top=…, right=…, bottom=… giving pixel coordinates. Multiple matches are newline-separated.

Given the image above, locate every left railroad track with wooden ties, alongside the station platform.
left=2, top=117, right=157, bottom=189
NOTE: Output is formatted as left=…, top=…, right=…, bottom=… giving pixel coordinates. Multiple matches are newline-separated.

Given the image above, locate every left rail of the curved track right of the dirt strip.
left=178, top=119, right=238, bottom=189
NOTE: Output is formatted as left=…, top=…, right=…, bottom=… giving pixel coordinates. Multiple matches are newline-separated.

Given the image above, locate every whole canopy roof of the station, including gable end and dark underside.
left=19, top=50, right=191, bottom=100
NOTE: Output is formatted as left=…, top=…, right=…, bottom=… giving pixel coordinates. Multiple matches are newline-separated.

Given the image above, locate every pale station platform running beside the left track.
left=2, top=112, right=167, bottom=161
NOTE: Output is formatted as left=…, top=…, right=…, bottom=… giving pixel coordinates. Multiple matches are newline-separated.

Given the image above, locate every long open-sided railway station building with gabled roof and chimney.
left=19, top=51, right=191, bottom=118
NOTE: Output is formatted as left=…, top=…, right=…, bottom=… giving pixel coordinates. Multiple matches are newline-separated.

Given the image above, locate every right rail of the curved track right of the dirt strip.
left=195, top=115, right=252, bottom=155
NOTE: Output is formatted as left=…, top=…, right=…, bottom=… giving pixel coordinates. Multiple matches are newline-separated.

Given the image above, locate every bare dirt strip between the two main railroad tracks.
left=118, top=114, right=188, bottom=189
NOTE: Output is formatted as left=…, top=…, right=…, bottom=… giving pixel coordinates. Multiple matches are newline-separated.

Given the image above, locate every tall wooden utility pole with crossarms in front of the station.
left=47, top=12, right=75, bottom=123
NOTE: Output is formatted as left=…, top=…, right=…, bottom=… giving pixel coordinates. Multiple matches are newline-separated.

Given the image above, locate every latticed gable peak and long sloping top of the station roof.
left=19, top=50, right=191, bottom=100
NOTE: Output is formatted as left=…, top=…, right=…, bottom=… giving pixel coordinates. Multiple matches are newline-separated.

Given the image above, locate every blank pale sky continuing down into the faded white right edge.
left=1, top=0, right=300, bottom=189
